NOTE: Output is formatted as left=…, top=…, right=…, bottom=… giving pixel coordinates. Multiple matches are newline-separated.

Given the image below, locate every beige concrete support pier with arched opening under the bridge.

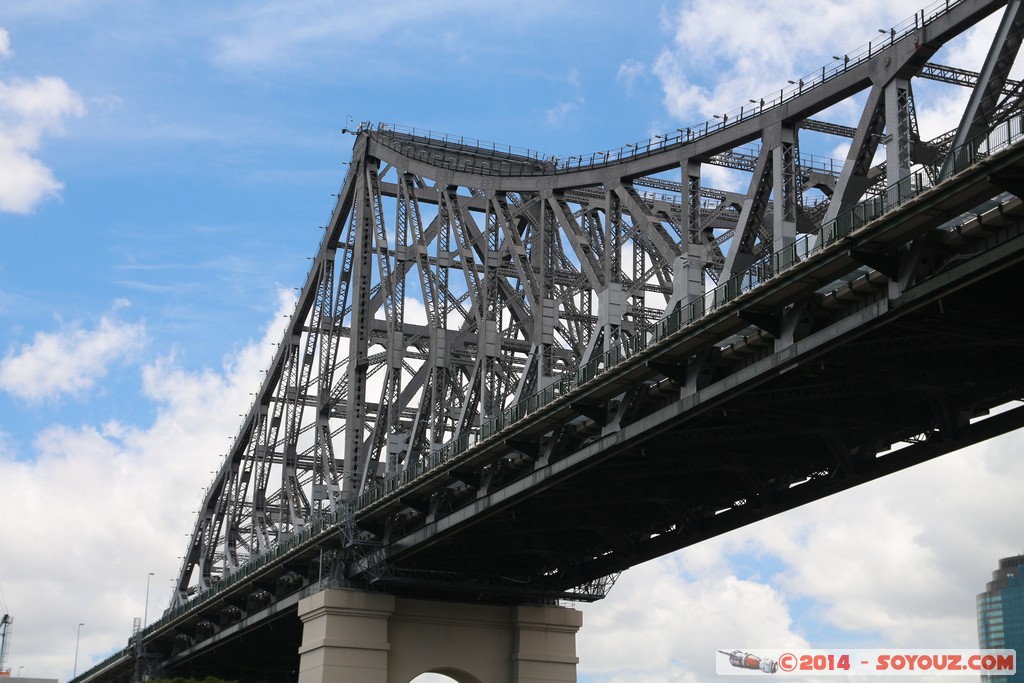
left=299, top=590, right=583, bottom=683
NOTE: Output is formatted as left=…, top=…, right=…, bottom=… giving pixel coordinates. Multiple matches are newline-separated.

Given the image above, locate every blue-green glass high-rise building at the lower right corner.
left=978, top=555, right=1024, bottom=683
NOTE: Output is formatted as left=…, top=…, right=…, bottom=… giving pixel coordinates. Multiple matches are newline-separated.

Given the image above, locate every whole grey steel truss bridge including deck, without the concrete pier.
left=78, top=0, right=1024, bottom=681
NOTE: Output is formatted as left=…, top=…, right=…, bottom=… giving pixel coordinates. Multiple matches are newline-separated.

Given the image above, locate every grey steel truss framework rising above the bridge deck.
left=173, top=0, right=1021, bottom=604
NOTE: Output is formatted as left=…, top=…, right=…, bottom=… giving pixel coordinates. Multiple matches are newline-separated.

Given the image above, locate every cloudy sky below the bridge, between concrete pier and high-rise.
left=578, top=433, right=1024, bottom=683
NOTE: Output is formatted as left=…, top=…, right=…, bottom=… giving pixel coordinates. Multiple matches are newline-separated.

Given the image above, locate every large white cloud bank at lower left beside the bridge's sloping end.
left=0, top=293, right=294, bottom=680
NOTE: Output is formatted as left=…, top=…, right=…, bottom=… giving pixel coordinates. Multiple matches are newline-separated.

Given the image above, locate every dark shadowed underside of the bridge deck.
left=380, top=252, right=1024, bottom=593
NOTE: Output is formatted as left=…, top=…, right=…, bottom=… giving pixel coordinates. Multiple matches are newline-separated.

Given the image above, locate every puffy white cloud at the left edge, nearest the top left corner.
left=0, top=29, right=85, bottom=213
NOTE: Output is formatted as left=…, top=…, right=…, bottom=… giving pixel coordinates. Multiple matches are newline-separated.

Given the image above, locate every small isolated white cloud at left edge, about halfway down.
left=0, top=302, right=146, bottom=401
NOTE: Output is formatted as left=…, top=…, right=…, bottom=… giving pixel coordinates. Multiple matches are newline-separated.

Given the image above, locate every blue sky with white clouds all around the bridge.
left=0, top=0, right=1024, bottom=683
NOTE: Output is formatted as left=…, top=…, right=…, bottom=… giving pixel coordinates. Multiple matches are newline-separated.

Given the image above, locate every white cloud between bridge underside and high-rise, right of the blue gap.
left=750, top=434, right=1024, bottom=647
